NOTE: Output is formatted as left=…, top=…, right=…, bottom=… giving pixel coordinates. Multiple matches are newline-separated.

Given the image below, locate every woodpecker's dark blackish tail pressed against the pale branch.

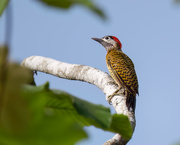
left=126, top=92, right=136, bottom=112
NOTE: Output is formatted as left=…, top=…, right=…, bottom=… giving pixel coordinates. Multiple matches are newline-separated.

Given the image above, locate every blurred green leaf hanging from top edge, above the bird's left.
left=39, top=0, right=106, bottom=19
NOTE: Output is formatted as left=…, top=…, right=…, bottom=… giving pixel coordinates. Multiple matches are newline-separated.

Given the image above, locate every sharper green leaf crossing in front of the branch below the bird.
left=48, top=87, right=132, bottom=139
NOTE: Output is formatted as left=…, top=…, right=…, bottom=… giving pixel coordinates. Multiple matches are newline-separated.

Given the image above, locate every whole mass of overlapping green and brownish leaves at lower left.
left=0, top=47, right=132, bottom=145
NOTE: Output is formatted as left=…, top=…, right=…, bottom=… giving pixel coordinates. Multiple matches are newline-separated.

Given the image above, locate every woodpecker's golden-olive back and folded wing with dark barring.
left=107, top=51, right=138, bottom=94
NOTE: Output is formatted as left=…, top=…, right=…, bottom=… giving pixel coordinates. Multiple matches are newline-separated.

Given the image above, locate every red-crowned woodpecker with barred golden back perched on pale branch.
left=92, top=36, right=139, bottom=111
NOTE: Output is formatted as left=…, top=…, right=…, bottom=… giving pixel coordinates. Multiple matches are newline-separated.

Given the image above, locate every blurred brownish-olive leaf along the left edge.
left=0, top=47, right=32, bottom=131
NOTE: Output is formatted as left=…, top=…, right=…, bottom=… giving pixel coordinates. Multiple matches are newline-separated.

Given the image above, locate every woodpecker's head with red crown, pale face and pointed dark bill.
left=92, top=36, right=122, bottom=51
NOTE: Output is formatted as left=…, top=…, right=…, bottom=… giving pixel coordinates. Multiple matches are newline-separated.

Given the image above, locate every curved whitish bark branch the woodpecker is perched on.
left=21, top=56, right=136, bottom=145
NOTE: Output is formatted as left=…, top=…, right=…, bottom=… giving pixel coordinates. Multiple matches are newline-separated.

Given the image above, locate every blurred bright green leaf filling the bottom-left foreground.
left=0, top=83, right=87, bottom=145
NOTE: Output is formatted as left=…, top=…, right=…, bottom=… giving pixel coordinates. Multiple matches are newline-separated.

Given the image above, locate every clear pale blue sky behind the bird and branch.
left=0, top=0, right=180, bottom=145
